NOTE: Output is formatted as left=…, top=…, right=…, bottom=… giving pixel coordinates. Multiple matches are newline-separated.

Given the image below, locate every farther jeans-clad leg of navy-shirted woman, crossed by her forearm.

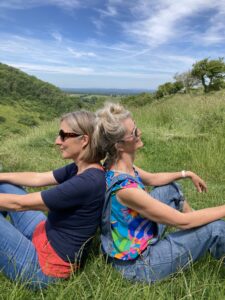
left=0, top=183, right=46, bottom=239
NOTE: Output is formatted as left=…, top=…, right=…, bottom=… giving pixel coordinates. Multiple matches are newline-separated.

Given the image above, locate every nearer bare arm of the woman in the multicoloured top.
left=117, top=188, right=225, bottom=229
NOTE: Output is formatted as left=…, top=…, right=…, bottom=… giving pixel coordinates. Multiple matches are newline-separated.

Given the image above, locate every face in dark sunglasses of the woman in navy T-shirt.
left=55, top=121, right=88, bottom=161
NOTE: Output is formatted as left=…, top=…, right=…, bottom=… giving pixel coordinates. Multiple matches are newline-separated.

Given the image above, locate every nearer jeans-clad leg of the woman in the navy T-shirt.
left=0, top=214, right=57, bottom=289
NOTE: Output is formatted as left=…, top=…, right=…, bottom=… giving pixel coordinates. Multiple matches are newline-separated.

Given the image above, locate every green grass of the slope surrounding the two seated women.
left=0, top=91, right=225, bottom=300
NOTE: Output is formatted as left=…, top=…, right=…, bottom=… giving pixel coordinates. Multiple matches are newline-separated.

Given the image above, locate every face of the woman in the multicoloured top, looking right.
left=118, top=118, right=143, bottom=152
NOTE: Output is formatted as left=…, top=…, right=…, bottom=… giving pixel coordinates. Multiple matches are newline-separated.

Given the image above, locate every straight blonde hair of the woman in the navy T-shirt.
left=60, top=110, right=105, bottom=163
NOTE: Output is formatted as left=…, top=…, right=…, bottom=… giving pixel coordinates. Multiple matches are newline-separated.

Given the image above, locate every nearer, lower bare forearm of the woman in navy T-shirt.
left=0, top=192, right=48, bottom=211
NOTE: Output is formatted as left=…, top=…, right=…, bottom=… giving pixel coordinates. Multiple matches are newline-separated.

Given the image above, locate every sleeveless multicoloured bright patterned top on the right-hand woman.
left=106, top=170, right=155, bottom=260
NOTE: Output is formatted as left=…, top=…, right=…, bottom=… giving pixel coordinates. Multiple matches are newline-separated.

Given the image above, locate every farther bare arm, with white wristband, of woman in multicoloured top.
left=135, top=166, right=207, bottom=193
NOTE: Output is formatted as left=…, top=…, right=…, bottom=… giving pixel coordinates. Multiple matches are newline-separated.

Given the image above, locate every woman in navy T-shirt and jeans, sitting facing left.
left=0, top=111, right=105, bottom=288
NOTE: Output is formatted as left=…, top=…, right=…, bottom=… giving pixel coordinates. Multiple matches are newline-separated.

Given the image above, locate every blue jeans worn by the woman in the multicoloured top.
left=112, top=183, right=225, bottom=283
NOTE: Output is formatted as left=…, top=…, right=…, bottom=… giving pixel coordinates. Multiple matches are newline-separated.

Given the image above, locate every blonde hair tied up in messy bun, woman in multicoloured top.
left=95, top=103, right=131, bottom=168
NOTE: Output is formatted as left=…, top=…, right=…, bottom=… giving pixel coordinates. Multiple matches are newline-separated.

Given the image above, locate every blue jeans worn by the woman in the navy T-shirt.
left=0, top=183, right=58, bottom=289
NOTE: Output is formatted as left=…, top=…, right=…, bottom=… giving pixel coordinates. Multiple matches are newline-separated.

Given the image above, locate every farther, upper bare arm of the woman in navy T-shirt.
left=0, top=171, right=58, bottom=187
